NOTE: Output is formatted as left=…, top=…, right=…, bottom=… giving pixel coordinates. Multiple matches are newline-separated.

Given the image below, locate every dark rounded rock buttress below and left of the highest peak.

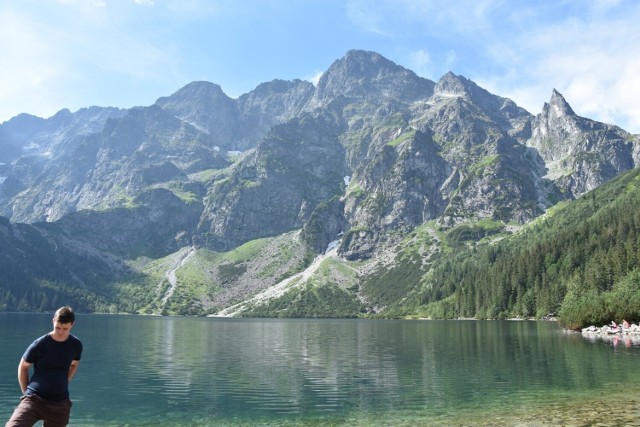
left=195, top=116, right=346, bottom=250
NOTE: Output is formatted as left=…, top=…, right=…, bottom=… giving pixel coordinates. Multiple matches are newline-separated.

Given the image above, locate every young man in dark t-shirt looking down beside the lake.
left=5, top=307, right=82, bottom=427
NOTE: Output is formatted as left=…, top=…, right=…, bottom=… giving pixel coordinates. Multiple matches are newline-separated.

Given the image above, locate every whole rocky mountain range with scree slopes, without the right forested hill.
left=0, top=50, right=640, bottom=316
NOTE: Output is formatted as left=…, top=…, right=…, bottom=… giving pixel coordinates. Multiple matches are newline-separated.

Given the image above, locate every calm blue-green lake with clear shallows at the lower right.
left=0, top=313, right=640, bottom=426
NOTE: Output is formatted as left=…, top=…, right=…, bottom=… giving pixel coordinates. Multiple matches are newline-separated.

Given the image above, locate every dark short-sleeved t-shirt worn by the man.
left=22, top=334, right=82, bottom=401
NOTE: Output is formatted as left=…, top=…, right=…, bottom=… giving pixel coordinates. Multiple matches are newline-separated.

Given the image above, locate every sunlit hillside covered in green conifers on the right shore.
left=419, top=170, right=640, bottom=328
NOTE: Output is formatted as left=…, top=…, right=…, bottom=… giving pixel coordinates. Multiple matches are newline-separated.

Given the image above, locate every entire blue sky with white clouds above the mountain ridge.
left=0, top=0, right=640, bottom=133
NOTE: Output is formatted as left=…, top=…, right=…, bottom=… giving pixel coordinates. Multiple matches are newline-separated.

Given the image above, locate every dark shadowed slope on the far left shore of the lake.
left=0, top=218, right=135, bottom=312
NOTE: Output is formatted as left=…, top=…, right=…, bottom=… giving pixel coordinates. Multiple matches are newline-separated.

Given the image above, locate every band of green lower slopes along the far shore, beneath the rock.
left=5, top=165, right=640, bottom=328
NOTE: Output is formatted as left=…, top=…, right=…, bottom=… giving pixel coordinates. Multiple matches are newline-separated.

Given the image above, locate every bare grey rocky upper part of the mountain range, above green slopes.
left=0, top=50, right=640, bottom=259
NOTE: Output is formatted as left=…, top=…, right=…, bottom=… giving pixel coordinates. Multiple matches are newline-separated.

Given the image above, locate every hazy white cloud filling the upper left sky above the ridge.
left=0, top=0, right=183, bottom=123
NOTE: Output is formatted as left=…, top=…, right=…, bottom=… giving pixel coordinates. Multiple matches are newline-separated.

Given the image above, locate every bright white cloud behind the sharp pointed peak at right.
left=498, top=2, right=640, bottom=132
